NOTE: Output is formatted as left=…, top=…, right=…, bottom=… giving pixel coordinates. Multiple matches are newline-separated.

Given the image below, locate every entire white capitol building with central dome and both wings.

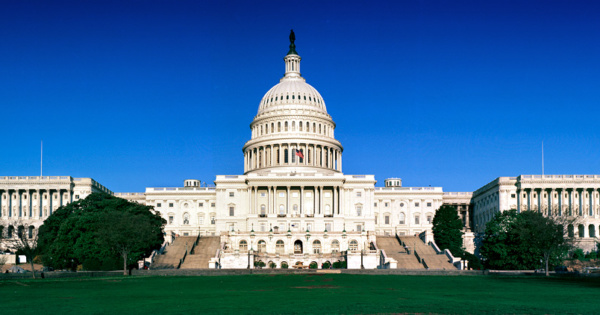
left=0, top=33, right=600, bottom=269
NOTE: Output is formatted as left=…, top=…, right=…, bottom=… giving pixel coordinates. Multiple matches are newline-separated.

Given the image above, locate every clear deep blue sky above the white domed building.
left=0, top=1, right=600, bottom=192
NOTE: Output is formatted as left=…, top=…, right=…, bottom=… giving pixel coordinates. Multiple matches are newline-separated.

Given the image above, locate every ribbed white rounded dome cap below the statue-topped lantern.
left=257, top=77, right=327, bottom=116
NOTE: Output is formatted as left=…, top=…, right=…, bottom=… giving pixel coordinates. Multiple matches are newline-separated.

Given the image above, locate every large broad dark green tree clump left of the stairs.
left=39, top=193, right=166, bottom=270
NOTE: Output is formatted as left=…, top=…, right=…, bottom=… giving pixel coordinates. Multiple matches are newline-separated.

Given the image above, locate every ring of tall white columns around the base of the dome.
left=244, top=143, right=342, bottom=172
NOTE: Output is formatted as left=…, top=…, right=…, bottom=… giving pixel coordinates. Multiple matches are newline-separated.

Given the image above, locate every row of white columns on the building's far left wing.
left=0, top=188, right=73, bottom=218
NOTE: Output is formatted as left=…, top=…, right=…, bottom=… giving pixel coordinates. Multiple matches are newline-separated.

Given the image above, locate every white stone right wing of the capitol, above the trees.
left=472, top=175, right=600, bottom=251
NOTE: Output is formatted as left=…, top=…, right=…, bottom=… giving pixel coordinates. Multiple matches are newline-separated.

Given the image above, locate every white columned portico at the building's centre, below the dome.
left=248, top=186, right=344, bottom=217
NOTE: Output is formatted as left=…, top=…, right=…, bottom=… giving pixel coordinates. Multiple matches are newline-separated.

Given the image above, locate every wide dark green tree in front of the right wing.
left=480, top=210, right=572, bottom=274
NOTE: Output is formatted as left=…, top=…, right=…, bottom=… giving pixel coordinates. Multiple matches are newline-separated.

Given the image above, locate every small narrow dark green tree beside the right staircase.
left=432, top=205, right=464, bottom=256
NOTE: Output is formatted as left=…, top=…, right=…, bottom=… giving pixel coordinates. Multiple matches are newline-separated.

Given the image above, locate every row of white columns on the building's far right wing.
left=517, top=188, right=600, bottom=217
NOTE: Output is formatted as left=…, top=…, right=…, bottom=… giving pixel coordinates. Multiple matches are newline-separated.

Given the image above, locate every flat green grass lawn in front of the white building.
left=0, top=274, right=600, bottom=314
